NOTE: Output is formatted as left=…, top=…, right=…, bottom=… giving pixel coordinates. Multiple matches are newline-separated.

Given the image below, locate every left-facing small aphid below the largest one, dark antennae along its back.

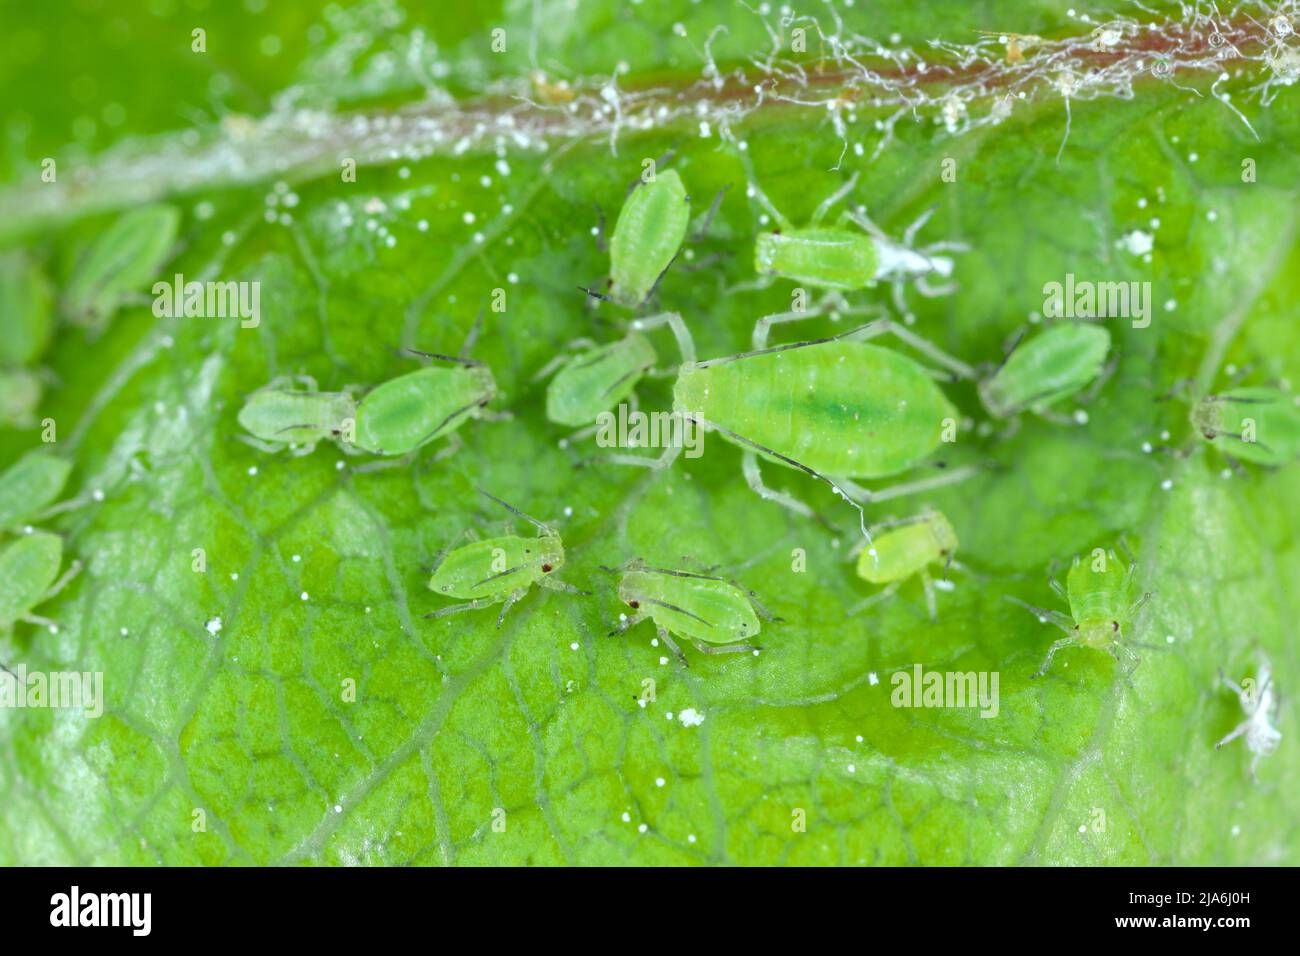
left=605, top=558, right=775, bottom=666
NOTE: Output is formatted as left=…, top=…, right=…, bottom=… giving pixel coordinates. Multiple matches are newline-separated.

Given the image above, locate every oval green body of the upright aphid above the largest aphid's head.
left=610, top=169, right=690, bottom=308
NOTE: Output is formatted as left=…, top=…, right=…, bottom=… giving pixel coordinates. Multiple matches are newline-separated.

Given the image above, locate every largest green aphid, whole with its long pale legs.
left=605, top=312, right=974, bottom=535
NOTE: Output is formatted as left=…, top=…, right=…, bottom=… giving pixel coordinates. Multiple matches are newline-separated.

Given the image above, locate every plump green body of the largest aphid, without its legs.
left=673, top=342, right=957, bottom=477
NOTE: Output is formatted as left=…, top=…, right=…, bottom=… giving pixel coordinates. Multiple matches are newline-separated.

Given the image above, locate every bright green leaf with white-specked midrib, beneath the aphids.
left=0, top=0, right=1300, bottom=865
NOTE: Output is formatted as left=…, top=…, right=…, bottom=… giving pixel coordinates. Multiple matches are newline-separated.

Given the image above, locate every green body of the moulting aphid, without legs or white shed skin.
left=754, top=229, right=880, bottom=291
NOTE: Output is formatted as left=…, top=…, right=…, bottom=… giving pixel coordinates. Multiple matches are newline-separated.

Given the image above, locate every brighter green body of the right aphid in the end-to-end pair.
left=356, top=365, right=495, bottom=455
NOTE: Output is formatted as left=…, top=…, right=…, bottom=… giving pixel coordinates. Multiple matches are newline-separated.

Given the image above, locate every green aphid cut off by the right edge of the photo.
left=1191, top=385, right=1300, bottom=466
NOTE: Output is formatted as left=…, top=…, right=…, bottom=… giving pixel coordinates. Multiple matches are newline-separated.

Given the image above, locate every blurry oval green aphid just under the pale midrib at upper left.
left=62, top=206, right=181, bottom=332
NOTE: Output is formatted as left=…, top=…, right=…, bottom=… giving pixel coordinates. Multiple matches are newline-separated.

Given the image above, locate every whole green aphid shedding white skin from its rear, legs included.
left=746, top=167, right=970, bottom=317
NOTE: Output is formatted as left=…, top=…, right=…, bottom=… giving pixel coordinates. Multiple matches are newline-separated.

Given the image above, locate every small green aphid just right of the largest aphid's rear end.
left=979, top=323, right=1110, bottom=420
